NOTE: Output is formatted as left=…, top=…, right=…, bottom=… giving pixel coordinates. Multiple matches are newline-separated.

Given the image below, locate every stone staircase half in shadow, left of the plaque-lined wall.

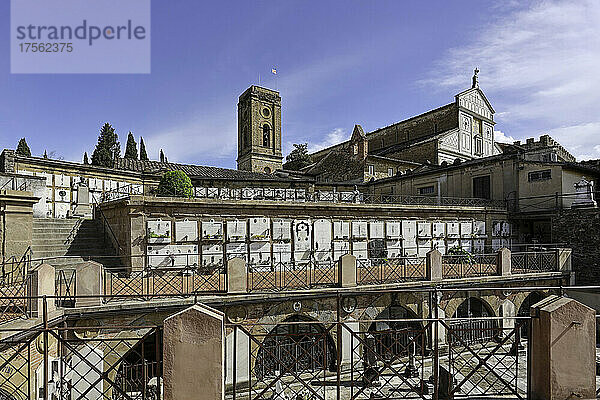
left=31, top=218, right=117, bottom=270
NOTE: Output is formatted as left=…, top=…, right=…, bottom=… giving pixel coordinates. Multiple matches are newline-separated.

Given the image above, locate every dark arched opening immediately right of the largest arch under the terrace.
left=369, top=305, right=426, bottom=361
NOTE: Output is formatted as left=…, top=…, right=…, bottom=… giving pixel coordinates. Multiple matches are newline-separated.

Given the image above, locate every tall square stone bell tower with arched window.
left=237, top=85, right=283, bottom=174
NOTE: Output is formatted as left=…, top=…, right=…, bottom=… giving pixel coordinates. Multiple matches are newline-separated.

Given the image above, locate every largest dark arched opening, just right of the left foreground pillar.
left=254, top=315, right=337, bottom=379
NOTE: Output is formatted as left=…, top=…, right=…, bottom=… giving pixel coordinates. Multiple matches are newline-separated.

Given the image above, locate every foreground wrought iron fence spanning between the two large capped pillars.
left=225, top=318, right=530, bottom=400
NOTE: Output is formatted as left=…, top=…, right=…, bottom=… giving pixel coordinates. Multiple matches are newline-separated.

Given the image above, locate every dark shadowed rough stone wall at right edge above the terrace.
left=552, top=208, right=600, bottom=285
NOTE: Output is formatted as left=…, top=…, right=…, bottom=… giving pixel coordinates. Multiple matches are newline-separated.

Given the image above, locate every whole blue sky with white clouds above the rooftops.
left=0, top=0, right=600, bottom=168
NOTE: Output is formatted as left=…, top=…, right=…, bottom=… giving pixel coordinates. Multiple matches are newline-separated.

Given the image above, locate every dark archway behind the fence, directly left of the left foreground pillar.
left=113, top=329, right=162, bottom=399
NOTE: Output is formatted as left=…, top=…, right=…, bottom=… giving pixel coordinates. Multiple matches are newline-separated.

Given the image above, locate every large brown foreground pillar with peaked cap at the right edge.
left=529, top=295, right=596, bottom=400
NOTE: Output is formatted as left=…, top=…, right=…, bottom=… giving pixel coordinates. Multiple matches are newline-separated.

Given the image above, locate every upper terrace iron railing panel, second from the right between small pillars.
left=442, top=253, right=498, bottom=279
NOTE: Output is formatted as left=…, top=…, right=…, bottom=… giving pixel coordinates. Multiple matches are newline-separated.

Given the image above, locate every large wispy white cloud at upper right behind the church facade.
left=422, top=0, right=600, bottom=161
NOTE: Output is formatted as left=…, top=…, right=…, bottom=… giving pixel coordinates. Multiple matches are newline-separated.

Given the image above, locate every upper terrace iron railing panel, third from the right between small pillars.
left=356, top=257, right=427, bottom=285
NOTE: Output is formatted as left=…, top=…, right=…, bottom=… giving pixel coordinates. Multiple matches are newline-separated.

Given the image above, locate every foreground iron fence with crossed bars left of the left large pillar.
left=0, top=321, right=162, bottom=400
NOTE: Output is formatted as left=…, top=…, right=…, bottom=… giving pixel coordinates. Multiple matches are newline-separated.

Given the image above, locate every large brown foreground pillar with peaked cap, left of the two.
left=163, top=304, right=225, bottom=400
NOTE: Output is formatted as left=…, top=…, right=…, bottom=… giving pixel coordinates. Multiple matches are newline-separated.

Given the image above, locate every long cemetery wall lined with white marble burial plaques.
left=102, top=196, right=514, bottom=269
